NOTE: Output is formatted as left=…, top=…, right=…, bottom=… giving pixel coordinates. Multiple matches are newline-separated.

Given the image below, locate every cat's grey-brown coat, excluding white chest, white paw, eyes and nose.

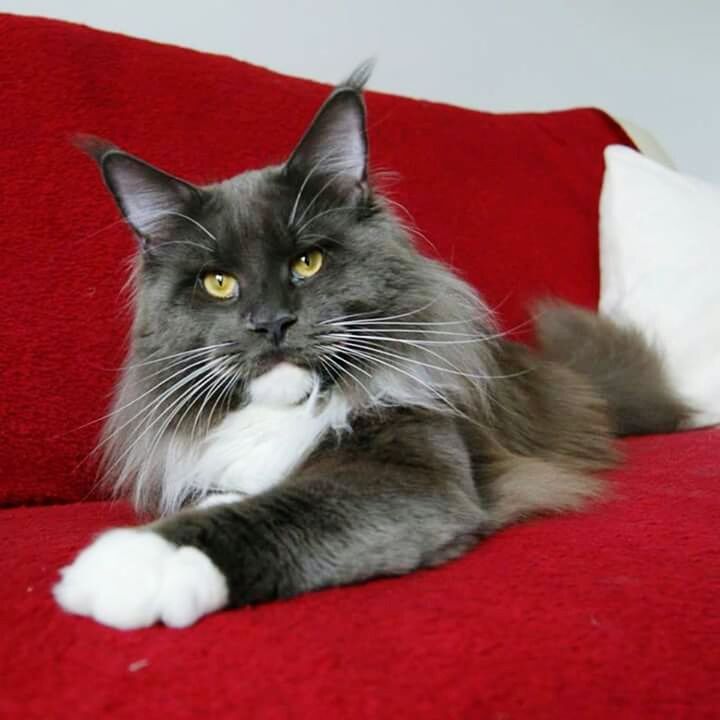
left=84, top=67, right=682, bottom=605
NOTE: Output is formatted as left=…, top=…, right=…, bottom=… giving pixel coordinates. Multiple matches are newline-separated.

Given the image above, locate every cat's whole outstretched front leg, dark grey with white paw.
left=55, top=414, right=490, bottom=628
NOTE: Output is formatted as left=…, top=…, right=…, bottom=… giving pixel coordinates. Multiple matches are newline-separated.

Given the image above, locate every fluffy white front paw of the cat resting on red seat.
left=53, top=528, right=228, bottom=630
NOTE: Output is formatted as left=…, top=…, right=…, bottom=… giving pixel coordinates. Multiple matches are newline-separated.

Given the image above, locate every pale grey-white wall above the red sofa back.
left=5, top=0, right=720, bottom=181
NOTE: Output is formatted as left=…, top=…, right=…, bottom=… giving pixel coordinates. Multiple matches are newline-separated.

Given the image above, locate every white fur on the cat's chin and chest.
left=164, top=363, right=349, bottom=509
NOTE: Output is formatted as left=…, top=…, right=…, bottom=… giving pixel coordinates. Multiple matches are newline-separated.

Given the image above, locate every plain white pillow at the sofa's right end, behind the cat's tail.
left=600, top=145, right=720, bottom=427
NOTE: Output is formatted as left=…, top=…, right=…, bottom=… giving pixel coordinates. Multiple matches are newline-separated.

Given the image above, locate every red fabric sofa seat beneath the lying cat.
left=0, top=431, right=720, bottom=720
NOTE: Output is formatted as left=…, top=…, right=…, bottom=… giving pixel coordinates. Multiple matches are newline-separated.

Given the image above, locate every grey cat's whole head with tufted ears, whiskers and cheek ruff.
left=82, top=65, right=496, bottom=510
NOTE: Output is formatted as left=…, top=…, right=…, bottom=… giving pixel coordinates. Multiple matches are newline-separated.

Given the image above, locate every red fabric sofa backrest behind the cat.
left=0, top=15, right=626, bottom=505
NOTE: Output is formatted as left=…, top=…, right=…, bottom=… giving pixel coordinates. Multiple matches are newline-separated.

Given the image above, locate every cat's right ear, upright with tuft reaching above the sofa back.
left=285, top=62, right=372, bottom=184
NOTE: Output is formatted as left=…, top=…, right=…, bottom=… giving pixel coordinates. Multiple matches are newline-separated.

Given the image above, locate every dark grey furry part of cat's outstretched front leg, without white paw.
left=153, top=459, right=490, bottom=607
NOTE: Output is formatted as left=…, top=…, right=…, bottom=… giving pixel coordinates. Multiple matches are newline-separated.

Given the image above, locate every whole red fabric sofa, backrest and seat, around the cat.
left=0, top=15, right=720, bottom=720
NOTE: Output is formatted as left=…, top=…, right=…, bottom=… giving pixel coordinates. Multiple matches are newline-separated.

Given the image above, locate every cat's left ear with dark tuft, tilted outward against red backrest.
left=75, top=135, right=201, bottom=246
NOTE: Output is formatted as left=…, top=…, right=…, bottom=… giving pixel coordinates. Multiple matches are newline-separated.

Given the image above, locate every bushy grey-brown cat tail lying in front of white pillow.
left=534, top=300, right=692, bottom=435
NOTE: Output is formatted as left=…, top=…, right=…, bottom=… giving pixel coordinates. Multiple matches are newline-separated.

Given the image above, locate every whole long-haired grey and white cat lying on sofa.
left=54, top=65, right=688, bottom=629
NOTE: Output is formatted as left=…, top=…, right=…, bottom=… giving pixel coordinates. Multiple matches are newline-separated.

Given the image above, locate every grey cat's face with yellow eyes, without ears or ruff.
left=123, top=162, right=414, bottom=388
